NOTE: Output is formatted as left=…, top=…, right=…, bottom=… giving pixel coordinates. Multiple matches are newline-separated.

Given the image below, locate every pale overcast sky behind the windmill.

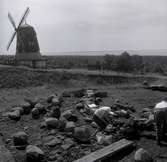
left=0, top=0, right=167, bottom=52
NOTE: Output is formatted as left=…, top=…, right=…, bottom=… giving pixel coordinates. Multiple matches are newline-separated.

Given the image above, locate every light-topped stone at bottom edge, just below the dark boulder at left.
left=26, top=145, right=45, bottom=162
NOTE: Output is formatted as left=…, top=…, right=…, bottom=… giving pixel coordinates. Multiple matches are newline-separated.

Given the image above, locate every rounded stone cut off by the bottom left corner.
left=0, top=145, right=15, bottom=162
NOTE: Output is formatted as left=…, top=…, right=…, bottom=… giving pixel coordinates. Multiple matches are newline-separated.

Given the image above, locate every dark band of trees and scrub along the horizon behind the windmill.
left=0, top=51, right=167, bottom=74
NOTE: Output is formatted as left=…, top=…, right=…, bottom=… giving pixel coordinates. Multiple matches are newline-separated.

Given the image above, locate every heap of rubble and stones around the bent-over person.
left=1, top=89, right=160, bottom=162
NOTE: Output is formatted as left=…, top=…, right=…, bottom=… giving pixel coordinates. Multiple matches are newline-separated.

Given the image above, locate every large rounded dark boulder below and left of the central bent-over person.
left=74, top=126, right=92, bottom=143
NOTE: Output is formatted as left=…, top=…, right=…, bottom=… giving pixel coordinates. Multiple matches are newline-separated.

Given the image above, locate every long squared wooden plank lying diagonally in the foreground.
left=74, top=139, right=134, bottom=162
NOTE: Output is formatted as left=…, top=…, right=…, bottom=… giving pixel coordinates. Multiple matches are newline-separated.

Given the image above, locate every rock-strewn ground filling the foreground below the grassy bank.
left=0, top=69, right=167, bottom=162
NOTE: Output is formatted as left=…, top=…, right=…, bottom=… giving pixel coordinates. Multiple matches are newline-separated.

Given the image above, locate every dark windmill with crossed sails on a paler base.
left=7, top=7, right=46, bottom=67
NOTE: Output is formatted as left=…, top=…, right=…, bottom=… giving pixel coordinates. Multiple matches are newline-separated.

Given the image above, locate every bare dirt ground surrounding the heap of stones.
left=0, top=84, right=167, bottom=162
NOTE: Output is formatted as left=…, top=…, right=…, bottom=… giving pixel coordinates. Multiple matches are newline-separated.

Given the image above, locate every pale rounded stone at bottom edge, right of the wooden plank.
left=134, top=148, right=153, bottom=162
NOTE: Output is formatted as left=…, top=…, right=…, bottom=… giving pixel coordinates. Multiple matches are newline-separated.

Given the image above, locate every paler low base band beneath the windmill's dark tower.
left=16, top=52, right=43, bottom=61
